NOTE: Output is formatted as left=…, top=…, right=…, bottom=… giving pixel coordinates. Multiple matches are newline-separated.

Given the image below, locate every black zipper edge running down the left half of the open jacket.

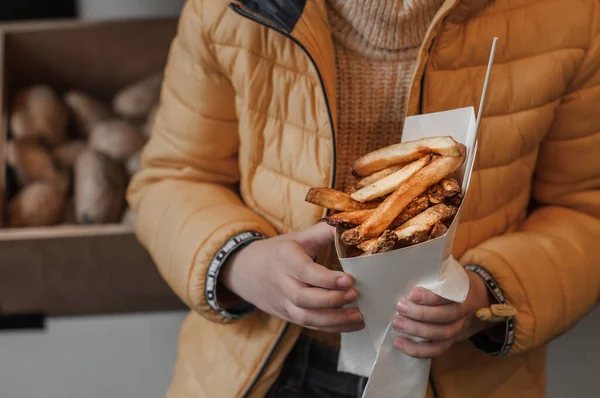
left=229, top=3, right=336, bottom=398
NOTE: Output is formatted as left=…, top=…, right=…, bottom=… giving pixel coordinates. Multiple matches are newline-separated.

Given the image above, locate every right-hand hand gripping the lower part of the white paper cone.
left=393, top=272, right=492, bottom=358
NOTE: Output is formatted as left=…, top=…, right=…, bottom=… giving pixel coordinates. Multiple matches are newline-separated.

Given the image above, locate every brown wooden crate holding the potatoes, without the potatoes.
left=0, top=19, right=183, bottom=315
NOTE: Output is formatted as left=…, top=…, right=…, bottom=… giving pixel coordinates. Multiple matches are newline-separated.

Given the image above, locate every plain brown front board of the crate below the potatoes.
left=0, top=233, right=183, bottom=315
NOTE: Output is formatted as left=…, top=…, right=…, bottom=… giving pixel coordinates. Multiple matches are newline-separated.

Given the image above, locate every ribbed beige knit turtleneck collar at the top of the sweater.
left=327, top=0, right=444, bottom=58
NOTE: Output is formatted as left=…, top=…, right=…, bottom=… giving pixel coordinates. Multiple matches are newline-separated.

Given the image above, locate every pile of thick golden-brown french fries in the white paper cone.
left=306, top=136, right=467, bottom=256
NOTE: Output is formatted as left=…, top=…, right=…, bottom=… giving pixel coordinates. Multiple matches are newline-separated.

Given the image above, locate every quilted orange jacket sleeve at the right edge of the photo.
left=461, top=24, right=600, bottom=355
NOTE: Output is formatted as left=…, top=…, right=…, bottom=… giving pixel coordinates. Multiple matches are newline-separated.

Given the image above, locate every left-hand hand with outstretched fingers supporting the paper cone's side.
left=221, top=223, right=364, bottom=332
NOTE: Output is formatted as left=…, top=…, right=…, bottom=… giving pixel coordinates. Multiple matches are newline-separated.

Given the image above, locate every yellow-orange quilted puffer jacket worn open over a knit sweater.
left=129, top=0, right=600, bottom=398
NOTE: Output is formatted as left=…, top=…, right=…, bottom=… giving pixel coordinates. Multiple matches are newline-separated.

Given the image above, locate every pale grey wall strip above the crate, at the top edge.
left=78, top=0, right=185, bottom=19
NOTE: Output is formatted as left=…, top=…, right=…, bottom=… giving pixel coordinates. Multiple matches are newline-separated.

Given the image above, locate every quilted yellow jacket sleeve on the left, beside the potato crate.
left=128, top=0, right=275, bottom=322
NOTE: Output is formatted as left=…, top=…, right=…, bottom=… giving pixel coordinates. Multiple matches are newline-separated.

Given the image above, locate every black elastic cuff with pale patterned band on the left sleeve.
left=205, top=231, right=265, bottom=319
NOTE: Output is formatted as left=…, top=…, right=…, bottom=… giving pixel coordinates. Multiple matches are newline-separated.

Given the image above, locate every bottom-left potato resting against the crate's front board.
left=8, top=181, right=65, bottom=227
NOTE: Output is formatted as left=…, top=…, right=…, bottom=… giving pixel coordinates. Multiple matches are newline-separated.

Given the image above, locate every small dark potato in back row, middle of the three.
left=65, top=91, right=112, bottom=137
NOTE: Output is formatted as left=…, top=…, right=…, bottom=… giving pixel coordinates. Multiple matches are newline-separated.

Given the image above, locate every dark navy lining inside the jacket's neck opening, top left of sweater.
left=240, top=0, right=306, bottom=33
